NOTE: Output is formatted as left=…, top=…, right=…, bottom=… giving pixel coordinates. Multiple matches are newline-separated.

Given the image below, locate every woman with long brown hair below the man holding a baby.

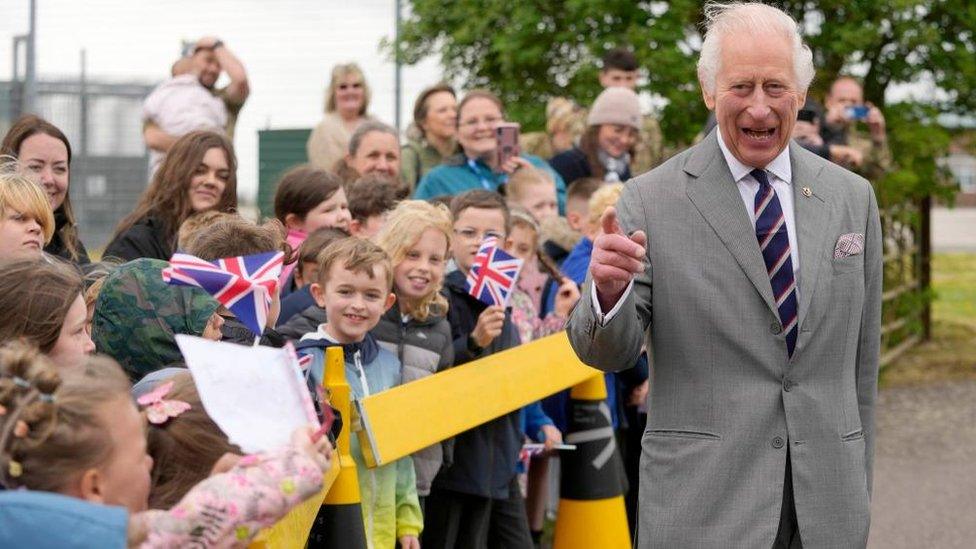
left=105, top=131, right=237, bottom=261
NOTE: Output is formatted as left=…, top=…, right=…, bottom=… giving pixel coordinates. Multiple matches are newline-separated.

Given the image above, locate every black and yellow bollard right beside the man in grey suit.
left=553, top=374, right=631, bottom=549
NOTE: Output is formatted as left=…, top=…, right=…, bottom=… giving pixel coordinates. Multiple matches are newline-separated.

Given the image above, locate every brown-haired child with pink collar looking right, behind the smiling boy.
left=274, top=165, right=352, bottom=296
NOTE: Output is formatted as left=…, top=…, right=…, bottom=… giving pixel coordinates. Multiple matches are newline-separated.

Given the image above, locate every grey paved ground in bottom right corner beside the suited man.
left=868, top=378, right=976, bottom=549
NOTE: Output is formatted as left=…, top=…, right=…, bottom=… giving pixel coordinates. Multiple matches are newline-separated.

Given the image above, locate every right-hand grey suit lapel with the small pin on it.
left=790, top=142, right=831, bottom=329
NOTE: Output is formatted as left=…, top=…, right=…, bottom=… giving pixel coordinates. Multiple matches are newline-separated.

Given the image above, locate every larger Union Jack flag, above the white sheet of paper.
left=163, top=252, right=285, bottom=335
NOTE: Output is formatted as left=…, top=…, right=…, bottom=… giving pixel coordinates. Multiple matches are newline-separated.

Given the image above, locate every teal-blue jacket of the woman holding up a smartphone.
left=413, top=154, right=566, bottom=215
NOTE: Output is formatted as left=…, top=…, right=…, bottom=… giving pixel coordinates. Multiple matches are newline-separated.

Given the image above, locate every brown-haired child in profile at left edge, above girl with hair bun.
left=0, top=258, right=95, bottom=368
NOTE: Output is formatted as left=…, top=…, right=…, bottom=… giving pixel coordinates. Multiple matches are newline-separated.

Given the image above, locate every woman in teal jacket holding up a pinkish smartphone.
left=414, top=90, right=566, bottom=214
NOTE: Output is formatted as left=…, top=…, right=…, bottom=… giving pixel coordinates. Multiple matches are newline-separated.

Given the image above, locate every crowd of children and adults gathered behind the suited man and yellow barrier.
left=0, top=7, right=890, bottom=549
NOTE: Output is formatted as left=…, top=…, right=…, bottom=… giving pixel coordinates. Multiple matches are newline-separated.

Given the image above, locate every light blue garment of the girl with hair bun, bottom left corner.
left=0, top=490, right=129, bottom=549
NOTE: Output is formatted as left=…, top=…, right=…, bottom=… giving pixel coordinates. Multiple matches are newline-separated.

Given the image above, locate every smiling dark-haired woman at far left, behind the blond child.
left=0, top=114, right=90, bottom=265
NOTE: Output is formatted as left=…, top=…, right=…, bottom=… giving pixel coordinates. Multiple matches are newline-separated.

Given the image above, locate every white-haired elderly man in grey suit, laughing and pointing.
left=569, top=4, right=882, bottom=549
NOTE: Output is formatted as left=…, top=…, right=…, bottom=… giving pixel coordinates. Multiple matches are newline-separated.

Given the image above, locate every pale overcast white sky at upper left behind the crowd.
left=0, top=0, right=441, bottom=201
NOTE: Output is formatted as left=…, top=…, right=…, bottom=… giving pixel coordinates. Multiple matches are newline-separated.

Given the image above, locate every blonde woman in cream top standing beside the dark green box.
left=305, top=63, right=373, bottom=171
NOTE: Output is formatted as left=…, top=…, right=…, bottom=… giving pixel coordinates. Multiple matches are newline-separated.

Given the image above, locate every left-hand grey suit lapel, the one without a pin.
left=684, top=130, right=776, bottom=318
